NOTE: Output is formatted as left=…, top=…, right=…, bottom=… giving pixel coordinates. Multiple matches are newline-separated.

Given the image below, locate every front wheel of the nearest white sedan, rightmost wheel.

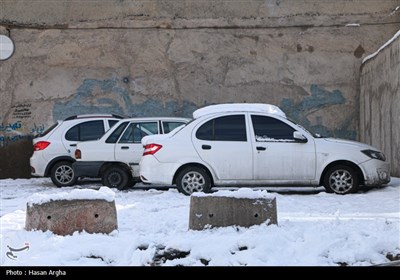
left=324, top=165, right=359, bottom=194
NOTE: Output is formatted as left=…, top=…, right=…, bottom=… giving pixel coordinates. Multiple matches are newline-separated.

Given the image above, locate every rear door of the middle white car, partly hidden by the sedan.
left=114, top=121, right=158, bottom=166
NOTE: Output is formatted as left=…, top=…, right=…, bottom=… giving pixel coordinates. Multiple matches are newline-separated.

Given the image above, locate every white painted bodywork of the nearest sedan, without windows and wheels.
left=140, top=104, right=390, bottom=195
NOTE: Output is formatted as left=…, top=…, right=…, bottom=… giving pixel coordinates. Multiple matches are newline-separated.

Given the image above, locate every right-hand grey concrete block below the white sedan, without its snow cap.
left=189, top=196, right=278, bottom=230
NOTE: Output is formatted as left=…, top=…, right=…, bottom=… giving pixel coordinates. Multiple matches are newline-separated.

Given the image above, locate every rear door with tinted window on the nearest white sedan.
left=192, top=114, right=253, bottom=180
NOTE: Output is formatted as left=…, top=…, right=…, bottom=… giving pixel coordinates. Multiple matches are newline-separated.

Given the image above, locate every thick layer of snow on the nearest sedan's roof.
left=193, top=103, right=286, bottom=119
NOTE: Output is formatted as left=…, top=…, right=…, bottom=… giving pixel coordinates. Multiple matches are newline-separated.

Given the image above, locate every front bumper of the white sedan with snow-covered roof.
left=360, top=159, right=390, bottom=187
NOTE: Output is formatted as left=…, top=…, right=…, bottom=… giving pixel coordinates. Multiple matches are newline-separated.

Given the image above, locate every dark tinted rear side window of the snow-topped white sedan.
left=196, top=115, right=247, bottom=141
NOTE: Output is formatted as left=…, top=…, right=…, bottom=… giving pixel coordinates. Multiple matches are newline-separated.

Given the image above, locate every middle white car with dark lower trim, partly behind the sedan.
left=72, top=117, right=189, bottom=189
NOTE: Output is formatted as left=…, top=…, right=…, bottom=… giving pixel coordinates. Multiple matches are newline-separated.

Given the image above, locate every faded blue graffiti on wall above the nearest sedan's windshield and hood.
left=280, top=85, right=357, bottom=140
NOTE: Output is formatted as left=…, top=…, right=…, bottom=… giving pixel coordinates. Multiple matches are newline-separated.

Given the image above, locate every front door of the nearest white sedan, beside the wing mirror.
left=251, top=114, right=316, bottom=180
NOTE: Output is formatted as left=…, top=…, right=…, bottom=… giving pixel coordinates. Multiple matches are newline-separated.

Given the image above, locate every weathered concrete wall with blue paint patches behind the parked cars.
left=0, top=0, right=400, bottom=177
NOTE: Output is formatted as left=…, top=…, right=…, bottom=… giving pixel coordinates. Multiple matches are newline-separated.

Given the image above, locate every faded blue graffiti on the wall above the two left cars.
left=53, top=78, right=198, bottom=120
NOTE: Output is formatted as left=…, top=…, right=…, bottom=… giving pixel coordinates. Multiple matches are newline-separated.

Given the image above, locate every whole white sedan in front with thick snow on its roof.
left=140, top=103, right=390, bottom=195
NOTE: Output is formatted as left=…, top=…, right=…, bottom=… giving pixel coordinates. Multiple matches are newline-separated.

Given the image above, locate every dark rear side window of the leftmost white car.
left=65, top=120, right=104, bottom=141
